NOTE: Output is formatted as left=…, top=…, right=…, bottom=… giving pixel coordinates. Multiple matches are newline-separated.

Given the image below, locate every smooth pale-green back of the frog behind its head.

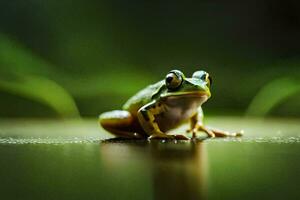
left=123, top=81, right=164, bottom=114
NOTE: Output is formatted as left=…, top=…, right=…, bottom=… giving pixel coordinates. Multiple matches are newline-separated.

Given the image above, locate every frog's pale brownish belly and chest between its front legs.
left=155, top=104, right=199, bottom=132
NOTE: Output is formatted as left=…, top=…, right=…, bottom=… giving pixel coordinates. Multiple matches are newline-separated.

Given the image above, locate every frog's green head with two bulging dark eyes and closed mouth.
left=161, top=70, right=212, bottom=103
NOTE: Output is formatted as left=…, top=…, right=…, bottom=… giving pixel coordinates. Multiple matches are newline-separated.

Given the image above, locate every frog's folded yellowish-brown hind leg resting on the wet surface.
left=99, top=110, right=145, bottom=139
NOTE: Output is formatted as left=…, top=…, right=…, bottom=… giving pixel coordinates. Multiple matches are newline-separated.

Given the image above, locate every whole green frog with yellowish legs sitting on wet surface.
left=99, top=69, right=242, bottom=140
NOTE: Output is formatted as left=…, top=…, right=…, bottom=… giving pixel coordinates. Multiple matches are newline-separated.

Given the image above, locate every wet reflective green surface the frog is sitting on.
left=0, top=118, right=300, bottom=199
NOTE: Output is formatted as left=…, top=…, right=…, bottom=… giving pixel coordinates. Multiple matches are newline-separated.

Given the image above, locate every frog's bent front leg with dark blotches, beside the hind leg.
left=137, top=102, right=189, bottom=140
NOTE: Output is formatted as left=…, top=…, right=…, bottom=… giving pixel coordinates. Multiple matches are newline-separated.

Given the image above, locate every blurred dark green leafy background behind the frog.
left=0, top=0, right=300, bottom=118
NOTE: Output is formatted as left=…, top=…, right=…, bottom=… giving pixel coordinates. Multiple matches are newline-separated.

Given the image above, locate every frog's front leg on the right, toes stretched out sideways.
left=188, top=107, right=242, bottom=138
